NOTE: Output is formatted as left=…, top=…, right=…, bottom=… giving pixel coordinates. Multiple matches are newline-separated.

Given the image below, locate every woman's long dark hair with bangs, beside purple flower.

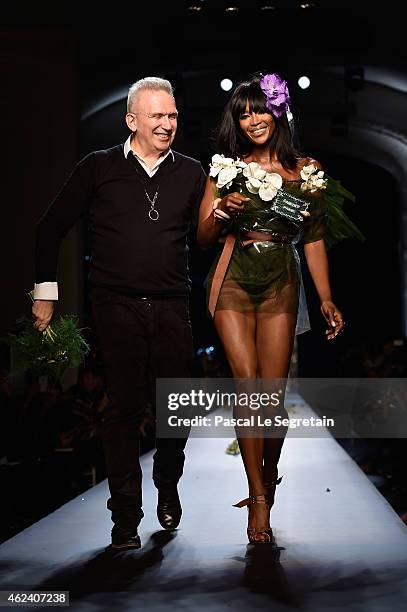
left=216, top=76, right=301, bottom=170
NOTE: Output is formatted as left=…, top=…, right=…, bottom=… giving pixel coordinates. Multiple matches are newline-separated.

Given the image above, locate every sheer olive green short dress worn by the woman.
left=206, top=175, right=363, bottom=334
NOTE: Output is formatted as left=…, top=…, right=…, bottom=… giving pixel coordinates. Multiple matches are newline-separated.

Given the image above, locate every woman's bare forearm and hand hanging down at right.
left=304, top=239, right=344, bottom=340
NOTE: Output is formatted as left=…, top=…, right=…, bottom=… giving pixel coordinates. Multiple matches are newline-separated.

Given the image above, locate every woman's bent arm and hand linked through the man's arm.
left=197, top=176, right=248, bottom=249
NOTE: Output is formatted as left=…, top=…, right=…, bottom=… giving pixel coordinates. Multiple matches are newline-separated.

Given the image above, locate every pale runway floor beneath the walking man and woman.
left=0, top=394, right=407, bottom=612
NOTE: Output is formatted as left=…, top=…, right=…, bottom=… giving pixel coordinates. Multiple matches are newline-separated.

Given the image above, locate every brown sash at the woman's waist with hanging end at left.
left=208, top=232, right=293, bottom=317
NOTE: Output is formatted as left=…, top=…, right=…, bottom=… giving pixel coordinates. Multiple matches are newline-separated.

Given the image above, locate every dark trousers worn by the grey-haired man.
left=91, top=286, right=193, bottom=533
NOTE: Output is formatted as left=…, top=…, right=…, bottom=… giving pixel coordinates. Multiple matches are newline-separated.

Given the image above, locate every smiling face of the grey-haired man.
left=126, top=89, right=177, bottom=155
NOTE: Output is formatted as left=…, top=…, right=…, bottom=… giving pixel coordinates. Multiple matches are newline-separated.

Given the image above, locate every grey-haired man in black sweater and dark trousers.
left=32, top=77, right=205, bottom=548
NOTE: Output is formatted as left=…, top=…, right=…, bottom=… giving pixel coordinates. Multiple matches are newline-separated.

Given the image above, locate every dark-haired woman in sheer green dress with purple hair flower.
left=198, top=74, right=344, bottom=543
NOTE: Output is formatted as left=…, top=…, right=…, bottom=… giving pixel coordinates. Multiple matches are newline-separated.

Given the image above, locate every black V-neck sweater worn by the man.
left=35, top=145, right=205, bottom=295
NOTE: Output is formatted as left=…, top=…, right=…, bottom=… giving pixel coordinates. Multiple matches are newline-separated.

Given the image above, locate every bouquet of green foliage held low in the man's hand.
left=3, top=291, right=90, bottom=381
